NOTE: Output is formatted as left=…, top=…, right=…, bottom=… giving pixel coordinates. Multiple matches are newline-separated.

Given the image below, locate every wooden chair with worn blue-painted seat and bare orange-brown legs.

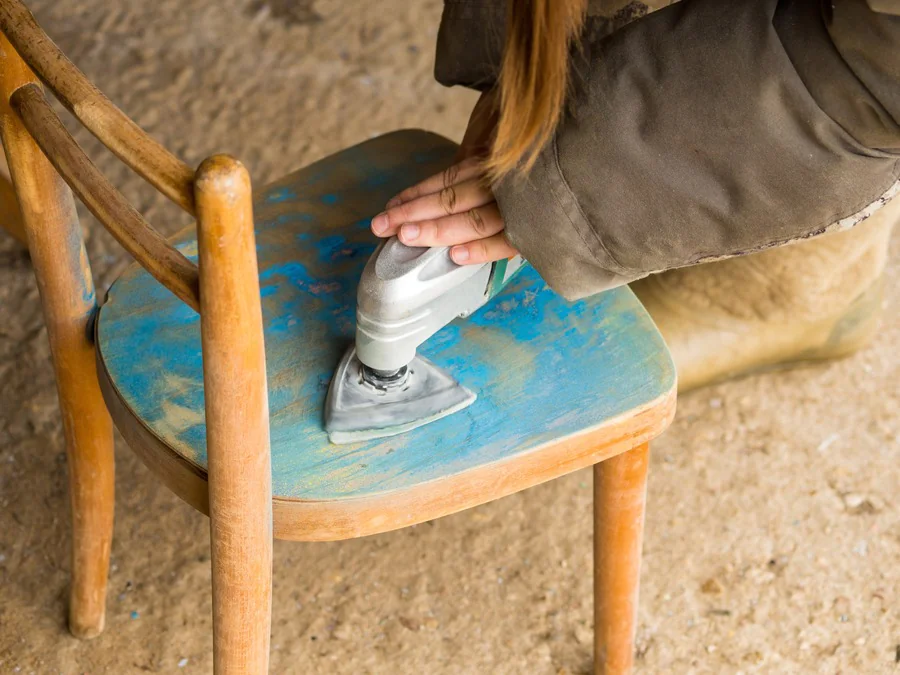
left=0, top=0, right=675, bottom=673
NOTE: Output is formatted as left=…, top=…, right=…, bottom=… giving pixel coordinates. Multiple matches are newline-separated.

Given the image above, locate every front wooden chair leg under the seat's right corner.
left=594, top=443, right=650, bottom=675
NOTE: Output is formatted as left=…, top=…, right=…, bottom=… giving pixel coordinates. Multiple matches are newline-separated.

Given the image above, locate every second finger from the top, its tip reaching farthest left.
left=372, top=179, right=494, bottom=237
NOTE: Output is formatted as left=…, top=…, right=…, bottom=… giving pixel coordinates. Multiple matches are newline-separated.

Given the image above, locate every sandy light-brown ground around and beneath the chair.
left=0, top=0, right=900, bottom=675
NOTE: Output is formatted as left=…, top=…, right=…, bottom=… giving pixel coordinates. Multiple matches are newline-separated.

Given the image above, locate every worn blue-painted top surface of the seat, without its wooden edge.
left=98, top=132, right=674, bottom=499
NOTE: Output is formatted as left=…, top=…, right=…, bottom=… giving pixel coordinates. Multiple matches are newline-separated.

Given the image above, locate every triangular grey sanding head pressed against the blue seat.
left=325, top=347, right=476, bottom=444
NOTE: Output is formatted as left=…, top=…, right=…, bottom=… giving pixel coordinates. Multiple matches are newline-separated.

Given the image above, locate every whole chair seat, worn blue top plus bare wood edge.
left=96, top=131, right=675, bottom=540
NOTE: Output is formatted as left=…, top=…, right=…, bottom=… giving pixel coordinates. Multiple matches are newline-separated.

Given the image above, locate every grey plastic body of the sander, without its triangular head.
left=356, top=237, right=492, bottom=371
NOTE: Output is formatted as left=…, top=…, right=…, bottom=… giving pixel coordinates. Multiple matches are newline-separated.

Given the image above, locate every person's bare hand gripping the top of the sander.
left=372, top=92, right=517, bottom=265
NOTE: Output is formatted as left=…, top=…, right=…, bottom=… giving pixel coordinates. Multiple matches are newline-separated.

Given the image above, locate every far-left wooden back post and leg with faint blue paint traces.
left=0, top=36, right=114, bottom=638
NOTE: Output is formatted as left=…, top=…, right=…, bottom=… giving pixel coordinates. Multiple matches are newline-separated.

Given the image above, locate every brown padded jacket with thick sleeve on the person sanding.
left=435, top=0, right=900, bottom=299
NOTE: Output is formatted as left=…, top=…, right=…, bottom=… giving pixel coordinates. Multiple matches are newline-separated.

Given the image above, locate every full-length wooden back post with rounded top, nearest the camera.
left=194, top=155, right=272, bottom=675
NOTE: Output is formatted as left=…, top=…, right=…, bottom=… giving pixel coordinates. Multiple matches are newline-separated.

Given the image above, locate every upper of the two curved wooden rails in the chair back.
left=0, top=0, right=194, bottom=215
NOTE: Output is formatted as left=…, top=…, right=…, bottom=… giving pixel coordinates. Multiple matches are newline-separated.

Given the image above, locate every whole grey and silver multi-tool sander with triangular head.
left=325, top=237, right=525, bottom=443
